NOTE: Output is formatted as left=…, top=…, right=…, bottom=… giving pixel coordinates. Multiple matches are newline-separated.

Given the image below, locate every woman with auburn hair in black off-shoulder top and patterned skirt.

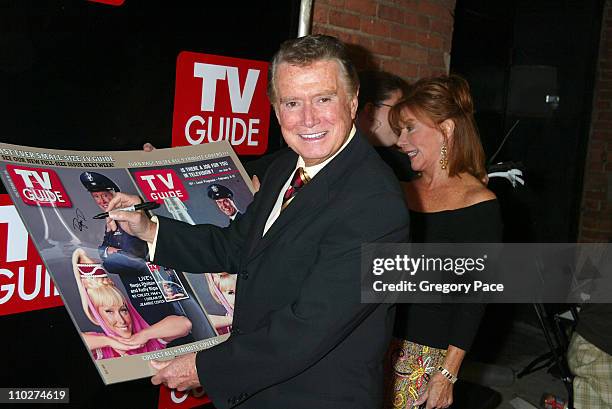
left=386, top=75, right=502, bottom=408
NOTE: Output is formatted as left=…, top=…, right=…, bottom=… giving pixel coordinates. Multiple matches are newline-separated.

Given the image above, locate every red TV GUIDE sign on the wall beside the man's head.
left=172, top=51, right=270, bottom=155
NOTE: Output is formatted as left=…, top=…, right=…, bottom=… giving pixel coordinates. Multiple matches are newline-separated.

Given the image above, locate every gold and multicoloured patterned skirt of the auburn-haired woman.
left=385, top=338, right=446, bottom=409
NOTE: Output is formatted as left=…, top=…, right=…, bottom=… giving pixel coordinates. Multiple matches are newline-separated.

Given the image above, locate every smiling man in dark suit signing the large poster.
left=107, top=35, right=408, bottom=409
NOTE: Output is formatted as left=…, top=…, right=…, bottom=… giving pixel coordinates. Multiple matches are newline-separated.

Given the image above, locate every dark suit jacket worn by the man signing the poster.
left=155, top=134, right=408, bottom=409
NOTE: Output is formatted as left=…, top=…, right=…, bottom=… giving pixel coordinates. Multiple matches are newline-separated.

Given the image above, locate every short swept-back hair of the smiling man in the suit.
left=268, top=35, right=359, bottom=104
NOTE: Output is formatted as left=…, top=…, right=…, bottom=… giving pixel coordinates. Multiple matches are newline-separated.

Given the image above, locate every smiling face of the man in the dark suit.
left=274, top=60, right=357, bottom=166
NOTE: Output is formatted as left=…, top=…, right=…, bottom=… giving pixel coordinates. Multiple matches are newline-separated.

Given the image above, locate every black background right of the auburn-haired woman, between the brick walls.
left=451, top=0, right=603, bottom=242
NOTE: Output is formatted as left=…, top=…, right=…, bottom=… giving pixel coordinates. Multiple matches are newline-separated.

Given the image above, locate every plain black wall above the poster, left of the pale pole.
left=0, top=0, right=299, bottom=150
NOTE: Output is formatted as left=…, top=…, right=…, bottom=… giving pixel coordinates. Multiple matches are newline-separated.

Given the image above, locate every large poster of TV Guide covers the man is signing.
left=0, top=141, right=253, bottom=384
